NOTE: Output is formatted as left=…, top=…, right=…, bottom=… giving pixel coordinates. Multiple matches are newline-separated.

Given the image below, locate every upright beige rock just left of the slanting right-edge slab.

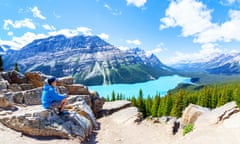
left=181, top=104, right=209, bottom=127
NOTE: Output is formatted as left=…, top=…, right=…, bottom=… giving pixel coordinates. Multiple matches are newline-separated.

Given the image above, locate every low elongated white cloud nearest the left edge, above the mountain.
left=3, top=18, right=36, bottom=30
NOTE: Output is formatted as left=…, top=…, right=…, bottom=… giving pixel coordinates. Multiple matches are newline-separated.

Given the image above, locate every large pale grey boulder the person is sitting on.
left=0, top=101, right=97, bottom=140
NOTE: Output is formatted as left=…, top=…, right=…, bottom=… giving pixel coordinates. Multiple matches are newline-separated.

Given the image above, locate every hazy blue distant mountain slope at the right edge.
left=172, top=53, right=240, bottom=75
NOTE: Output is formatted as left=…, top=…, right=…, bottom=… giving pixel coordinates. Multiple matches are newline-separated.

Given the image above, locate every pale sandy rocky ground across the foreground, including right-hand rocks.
left=0, top=101, right=240, bottom=144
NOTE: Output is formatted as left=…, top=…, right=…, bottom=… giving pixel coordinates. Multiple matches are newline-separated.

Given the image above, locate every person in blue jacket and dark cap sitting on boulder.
left=41, top=77, right=68, bottom=115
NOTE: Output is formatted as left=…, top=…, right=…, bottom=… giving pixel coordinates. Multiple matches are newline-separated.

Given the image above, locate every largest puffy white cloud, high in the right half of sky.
left=160, top=0, right=214, bottom=37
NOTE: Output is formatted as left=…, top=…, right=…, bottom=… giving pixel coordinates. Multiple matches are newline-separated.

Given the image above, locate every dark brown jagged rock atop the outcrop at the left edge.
left=1, top=70, right=28, bottom=84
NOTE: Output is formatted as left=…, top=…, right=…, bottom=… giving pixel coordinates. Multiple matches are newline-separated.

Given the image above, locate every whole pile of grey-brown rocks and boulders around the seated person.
left=0, top=71, right=104, bottom=141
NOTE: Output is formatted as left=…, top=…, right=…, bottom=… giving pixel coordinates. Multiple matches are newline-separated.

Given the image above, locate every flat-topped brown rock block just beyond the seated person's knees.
left=65, top=84, right=90, bottom=95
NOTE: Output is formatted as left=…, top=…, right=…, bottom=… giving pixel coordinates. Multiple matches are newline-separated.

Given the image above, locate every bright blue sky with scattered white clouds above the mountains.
left=0, top=0, right=240, bottom=65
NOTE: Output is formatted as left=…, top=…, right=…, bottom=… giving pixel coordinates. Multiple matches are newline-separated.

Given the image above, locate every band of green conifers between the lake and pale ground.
left=107, top=82, right=240, bottom=117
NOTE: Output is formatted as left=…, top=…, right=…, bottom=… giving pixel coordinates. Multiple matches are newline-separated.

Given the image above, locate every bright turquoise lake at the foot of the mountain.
left=88, top=75, right=191, bottom=98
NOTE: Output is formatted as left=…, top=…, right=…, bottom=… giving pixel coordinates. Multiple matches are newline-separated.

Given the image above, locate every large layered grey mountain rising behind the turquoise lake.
left=3, top=35, right=175, bottom=85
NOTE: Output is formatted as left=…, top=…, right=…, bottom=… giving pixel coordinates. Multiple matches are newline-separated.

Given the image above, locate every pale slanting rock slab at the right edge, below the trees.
left=195, top=102, right=239, bottom=128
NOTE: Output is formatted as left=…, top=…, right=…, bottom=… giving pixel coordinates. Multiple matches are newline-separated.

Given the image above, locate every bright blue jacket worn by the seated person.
left=41, top=84, right=66, bottom=109
